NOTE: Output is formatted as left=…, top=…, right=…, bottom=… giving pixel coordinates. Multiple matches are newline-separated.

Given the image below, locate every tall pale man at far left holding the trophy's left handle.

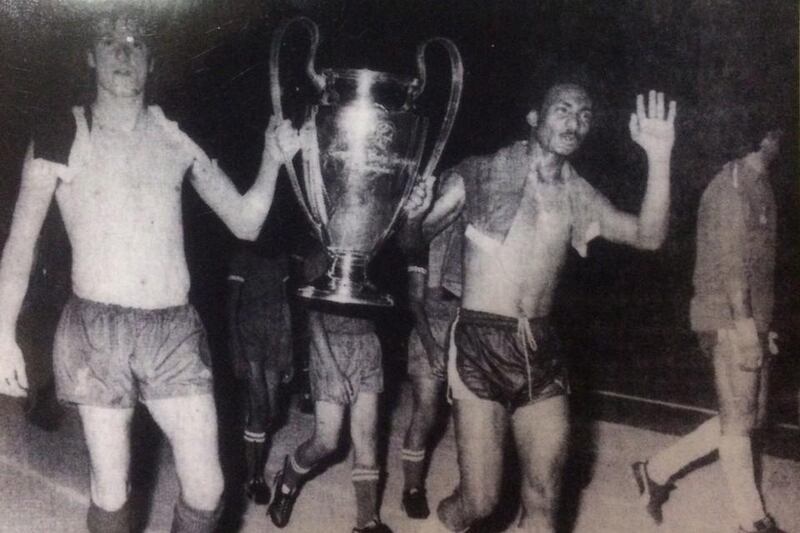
left=0, top=11, right=299, bottom=533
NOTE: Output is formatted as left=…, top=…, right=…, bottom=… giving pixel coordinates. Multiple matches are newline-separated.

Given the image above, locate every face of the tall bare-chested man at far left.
left=88, top=17, right=152, bottom=97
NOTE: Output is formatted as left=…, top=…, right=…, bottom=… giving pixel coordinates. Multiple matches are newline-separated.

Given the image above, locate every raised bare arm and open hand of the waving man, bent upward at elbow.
left=599, top=91, right=676, bottom=250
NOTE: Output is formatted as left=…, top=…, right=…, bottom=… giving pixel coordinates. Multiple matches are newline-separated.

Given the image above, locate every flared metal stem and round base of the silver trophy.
left=297, top=251, right=394, bottom=307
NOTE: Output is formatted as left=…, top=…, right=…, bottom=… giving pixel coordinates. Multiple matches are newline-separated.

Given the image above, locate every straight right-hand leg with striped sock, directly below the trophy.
left=350, top=392, right=380, bottom=528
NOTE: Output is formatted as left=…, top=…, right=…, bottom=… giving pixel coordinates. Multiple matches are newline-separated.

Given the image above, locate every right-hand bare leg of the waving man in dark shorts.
left=511, top=396, right=569, bottom=533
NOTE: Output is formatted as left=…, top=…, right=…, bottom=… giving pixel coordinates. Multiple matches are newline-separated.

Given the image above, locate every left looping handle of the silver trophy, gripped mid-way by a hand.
left=269, top=17, right=327, bottom=243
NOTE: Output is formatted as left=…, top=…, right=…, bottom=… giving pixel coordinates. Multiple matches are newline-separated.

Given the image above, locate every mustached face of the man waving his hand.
left=528, top=84, right=592, bottom=157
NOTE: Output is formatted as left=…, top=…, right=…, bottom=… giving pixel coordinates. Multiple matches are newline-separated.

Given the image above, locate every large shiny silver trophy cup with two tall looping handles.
left=270, top=17, right=463, bottom=306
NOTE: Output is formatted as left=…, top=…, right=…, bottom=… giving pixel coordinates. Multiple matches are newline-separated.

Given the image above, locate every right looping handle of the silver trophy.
left=410, top=37, right=464, bottom=187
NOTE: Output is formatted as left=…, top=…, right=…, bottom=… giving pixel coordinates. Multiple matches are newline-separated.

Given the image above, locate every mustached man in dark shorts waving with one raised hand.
left=423, top=79, right=676, bottom=533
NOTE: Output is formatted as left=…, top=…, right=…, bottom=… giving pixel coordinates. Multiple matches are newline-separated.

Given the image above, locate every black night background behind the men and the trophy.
left=0, top=0, right=800, bottom=429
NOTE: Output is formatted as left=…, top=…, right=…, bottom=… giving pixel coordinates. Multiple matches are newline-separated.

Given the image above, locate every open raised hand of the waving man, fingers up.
left=628, top=91, right=677, bottom=161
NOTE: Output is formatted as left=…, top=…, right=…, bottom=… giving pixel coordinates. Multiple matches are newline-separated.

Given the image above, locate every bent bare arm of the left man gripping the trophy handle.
left=192, top=118, right=299, bottom=241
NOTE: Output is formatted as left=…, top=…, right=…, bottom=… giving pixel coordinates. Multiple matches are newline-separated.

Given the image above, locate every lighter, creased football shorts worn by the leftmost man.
left=53, top=296, right=213, bottom=408
